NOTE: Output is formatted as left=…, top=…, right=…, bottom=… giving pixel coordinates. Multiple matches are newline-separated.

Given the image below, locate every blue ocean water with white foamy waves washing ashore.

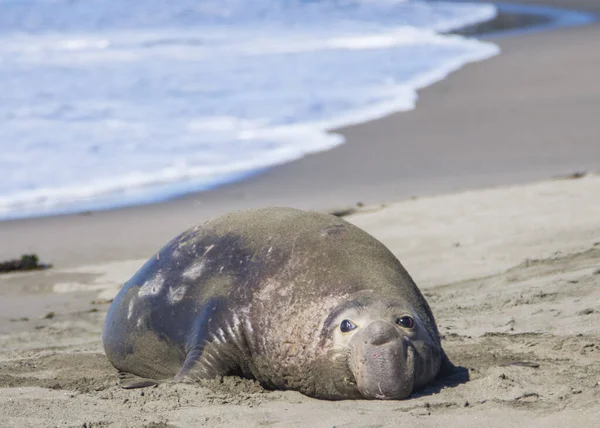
left=0, top=0, right=498, bottom=218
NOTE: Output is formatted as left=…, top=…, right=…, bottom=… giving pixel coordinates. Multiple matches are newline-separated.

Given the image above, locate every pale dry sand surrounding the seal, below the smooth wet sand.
left=0, top=176, right=600, bottom=428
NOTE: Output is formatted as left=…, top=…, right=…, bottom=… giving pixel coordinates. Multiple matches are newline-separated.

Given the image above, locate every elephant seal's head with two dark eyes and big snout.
left=327, top=299, right=445, bottom=400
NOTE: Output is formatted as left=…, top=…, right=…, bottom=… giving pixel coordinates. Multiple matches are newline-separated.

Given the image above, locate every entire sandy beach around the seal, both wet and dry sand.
left=0, top=0, right=600, bottom=427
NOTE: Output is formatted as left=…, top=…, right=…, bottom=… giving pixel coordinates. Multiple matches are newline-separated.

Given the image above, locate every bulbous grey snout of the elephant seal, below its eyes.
left=350, top=321, right=415, bottom=400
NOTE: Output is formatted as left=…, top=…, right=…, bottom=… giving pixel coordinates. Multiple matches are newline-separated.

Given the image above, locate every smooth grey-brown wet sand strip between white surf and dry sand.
left=0, top=0, right=600, bottom=266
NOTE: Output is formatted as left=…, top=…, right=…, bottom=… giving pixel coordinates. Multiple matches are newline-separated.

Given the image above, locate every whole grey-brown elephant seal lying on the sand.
left=103, top=208, right=453, bottom=399
